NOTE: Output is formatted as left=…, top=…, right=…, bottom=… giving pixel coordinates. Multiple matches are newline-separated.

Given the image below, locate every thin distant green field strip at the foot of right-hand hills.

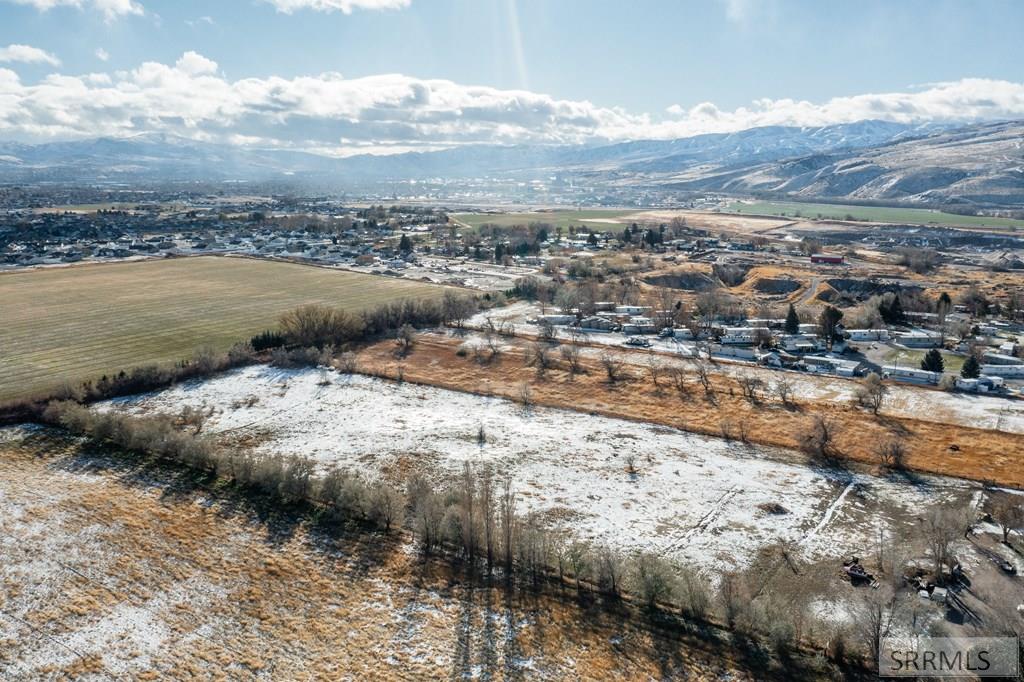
left=727, top=202, right=1024, bottom=229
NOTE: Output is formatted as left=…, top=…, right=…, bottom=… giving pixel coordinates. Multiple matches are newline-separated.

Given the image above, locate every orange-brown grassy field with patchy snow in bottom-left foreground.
left=0, top=428, right=764, bottom=681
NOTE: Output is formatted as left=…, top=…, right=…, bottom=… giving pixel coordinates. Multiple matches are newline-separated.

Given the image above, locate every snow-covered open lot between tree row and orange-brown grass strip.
left=102, top=367, right=975, bottom=573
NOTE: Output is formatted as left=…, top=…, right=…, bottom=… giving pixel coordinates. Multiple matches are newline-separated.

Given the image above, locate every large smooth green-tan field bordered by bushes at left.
left=0, top=257, right=444, bottom=400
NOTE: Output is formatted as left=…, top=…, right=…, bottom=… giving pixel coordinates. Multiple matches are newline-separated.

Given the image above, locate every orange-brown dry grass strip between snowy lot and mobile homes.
left=359, top=334, right=1024, bottom=487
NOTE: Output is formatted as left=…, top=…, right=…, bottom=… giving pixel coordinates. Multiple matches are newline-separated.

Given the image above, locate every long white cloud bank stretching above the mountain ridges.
left=0, top=51, right=1024, bottom=155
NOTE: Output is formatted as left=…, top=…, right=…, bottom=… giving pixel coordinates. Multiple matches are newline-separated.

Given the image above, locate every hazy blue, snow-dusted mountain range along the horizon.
left=0, top=121, right=1024, bottom=207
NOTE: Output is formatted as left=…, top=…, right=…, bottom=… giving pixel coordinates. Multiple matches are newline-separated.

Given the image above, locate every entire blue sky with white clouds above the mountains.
left=0, top=0, right=1024, bottom=155
